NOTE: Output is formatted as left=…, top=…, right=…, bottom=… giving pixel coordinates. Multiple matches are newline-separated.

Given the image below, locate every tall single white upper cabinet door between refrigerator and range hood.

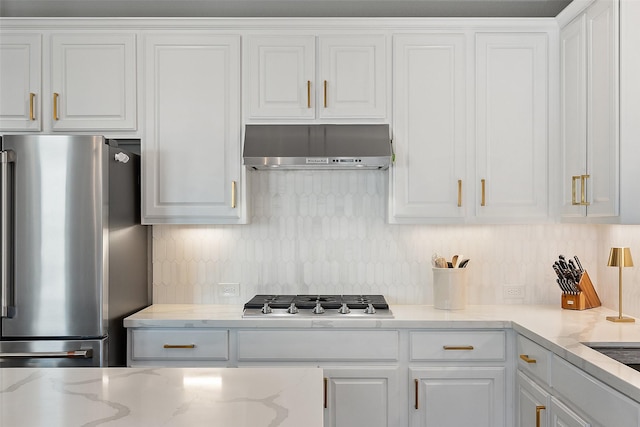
left=142, top=33, right=246, bottom=224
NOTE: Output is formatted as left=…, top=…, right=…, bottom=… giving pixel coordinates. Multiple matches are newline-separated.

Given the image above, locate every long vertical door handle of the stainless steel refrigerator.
left=0, top=151, right=15, bottom=317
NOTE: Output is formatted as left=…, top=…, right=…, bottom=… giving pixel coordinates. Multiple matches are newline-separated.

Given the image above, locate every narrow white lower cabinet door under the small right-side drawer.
left=516, top=371, right=551, bottom=427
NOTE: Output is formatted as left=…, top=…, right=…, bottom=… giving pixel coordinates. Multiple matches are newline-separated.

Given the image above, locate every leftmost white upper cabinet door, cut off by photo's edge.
left=0, top=33, right=42, bottom=131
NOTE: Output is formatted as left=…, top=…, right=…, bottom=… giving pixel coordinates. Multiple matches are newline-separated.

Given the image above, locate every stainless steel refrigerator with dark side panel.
left=0, top=135, right=149, bottom=367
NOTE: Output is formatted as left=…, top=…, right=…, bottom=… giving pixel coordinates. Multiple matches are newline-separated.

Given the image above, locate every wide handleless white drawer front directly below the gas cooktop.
left=238, top=330, right=398, bottom=362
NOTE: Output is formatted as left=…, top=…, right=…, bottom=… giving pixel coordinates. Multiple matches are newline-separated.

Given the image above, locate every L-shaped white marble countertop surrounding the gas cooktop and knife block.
left=124, top=304, right=640, bottom=402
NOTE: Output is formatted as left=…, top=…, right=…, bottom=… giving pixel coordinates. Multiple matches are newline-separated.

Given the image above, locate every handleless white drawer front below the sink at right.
left=551, top=355, right=640, bottom=427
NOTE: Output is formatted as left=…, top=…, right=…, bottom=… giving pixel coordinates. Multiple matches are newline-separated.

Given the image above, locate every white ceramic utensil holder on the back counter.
left=433, top=267, right=467, bottom=310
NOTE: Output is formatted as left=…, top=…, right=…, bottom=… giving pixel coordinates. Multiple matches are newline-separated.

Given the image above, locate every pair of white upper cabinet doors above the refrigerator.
left=0, top=32, right=137, bottom=132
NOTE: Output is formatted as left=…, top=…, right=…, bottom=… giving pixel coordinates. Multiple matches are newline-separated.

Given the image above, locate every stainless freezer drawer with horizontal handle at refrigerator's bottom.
left=0, top=338, right=107, bottom=368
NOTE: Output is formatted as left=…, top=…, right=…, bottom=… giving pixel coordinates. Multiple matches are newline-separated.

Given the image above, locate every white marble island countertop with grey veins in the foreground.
left=0, top=368, right=323, bottom=427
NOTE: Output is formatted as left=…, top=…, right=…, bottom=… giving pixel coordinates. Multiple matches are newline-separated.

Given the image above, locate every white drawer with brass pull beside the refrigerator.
left=131, top=329, right=229, bottom=360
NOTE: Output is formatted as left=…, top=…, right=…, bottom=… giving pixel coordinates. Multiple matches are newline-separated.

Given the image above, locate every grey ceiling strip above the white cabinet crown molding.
left=0, top=0, right=571, bottom=17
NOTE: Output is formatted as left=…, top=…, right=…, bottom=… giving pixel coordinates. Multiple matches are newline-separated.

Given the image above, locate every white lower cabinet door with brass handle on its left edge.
left=410, top=366, right=506, bottom=427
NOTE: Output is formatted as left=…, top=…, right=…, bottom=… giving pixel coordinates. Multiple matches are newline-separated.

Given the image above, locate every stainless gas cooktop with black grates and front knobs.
left=243, top=295, right=393, bottom=318
